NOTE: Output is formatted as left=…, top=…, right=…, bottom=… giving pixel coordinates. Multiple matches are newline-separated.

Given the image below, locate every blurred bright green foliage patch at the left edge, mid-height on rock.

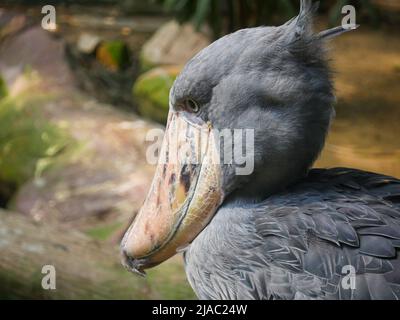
left=0, top=95, right=72, bottom=188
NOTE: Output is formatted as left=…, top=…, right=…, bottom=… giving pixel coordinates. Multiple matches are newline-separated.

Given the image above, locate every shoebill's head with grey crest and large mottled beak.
left=121, top=0, right=356, bottom=272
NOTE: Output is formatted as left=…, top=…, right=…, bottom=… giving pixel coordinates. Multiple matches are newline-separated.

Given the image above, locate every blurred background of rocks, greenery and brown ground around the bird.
left=0, top=0, right=400, bottom=299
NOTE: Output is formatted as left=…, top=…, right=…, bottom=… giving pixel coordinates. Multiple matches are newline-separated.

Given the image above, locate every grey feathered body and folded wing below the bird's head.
left=185, top=168, right=400, bottom=299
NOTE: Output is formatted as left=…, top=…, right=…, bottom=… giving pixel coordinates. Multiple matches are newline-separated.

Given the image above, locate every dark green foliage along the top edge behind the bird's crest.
left=153, top=0, right=380, bottom=38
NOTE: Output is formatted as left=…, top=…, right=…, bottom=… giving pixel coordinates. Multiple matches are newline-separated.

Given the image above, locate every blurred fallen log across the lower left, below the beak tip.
left=0, top=210, right=193, bottom=299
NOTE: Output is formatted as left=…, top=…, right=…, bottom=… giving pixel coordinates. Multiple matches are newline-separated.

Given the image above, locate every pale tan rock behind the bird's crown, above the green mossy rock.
left=140, top=21, right=210, bottom=71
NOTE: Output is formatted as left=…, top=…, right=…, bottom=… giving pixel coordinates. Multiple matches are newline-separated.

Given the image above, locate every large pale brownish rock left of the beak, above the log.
left=0, top=26, right=154, bottom=234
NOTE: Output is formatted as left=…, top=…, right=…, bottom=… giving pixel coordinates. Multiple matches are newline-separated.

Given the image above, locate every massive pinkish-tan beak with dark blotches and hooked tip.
left=121, top=111, right=223, bottom=273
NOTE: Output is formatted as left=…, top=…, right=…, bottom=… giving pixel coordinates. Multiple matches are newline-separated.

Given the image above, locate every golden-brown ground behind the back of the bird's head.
left=316, top=26, right=400, bottom=177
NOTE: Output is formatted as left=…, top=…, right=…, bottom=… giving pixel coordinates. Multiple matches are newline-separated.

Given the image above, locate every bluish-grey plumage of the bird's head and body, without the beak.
left=170, top=0, right=400, bottom=299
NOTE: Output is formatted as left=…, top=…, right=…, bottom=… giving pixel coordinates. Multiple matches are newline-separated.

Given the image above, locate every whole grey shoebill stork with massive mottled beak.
left=121, top=0, right=400, bottom=299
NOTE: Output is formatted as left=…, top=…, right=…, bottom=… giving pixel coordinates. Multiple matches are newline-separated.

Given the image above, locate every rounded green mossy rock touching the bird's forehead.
left=133, top=66, right=180, bottom=124
